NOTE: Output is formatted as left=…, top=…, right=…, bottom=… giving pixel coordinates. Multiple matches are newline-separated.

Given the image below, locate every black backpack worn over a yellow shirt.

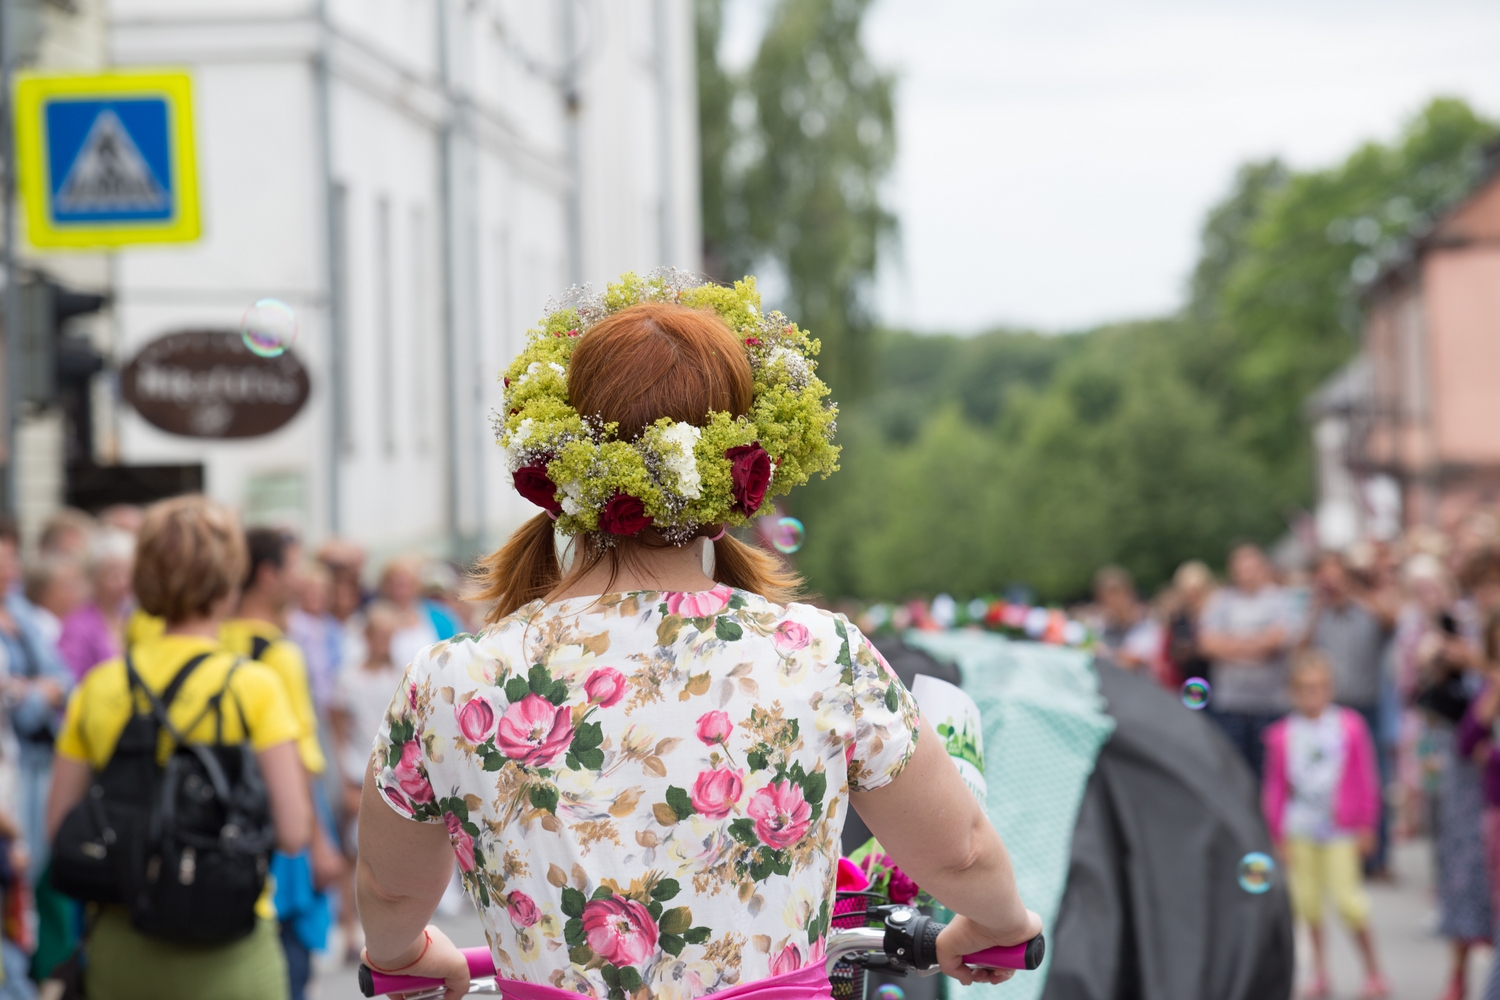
left=53, top=654, right=276, bottom=945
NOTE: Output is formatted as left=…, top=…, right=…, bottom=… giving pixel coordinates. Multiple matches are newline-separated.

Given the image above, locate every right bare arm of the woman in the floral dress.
left=851, top=718, right=1041, bottom=984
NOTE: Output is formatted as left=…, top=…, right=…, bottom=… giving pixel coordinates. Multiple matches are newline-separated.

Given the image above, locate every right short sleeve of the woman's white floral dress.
left=836, top=616, right=921, bottom=792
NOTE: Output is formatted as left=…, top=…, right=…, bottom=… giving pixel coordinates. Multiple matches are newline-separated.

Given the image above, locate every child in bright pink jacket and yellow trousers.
left=1262, top=649, right=1389, bottom=1000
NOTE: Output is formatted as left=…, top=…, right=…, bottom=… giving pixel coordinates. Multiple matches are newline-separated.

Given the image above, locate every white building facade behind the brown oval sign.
left=19, top=0, right=701, bottom=555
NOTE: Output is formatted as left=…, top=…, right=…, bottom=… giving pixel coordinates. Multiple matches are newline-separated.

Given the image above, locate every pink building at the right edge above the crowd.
left=1310, top=156, right=1500, bottom=544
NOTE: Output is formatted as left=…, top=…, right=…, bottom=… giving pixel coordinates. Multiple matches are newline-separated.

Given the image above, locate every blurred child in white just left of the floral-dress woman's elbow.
left=329, top=601, right=402, bottom=955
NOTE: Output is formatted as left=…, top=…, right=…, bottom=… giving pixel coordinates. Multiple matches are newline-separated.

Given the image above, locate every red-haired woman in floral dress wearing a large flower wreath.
left=357, top=274, right=1041, bottom=1000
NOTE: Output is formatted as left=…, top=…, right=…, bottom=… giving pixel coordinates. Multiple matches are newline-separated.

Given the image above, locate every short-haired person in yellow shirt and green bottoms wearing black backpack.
left=47, top=496, right=312, bottom=1000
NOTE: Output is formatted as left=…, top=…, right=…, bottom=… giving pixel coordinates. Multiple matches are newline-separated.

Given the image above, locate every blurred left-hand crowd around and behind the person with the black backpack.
left=0, top=505, right=482, bottom=997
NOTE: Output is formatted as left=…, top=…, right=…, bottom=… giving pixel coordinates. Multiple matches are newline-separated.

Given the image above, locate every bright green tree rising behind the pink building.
left=1206, top=99, right=1496, bottom=504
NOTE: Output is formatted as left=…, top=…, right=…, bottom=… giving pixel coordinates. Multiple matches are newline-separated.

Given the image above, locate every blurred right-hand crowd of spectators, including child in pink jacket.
left=1085, top=524, right=1500, bottom=1000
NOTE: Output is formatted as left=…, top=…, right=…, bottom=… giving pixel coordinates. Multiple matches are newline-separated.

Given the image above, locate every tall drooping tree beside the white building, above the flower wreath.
left=698, top=0, right=896, bottom=400
